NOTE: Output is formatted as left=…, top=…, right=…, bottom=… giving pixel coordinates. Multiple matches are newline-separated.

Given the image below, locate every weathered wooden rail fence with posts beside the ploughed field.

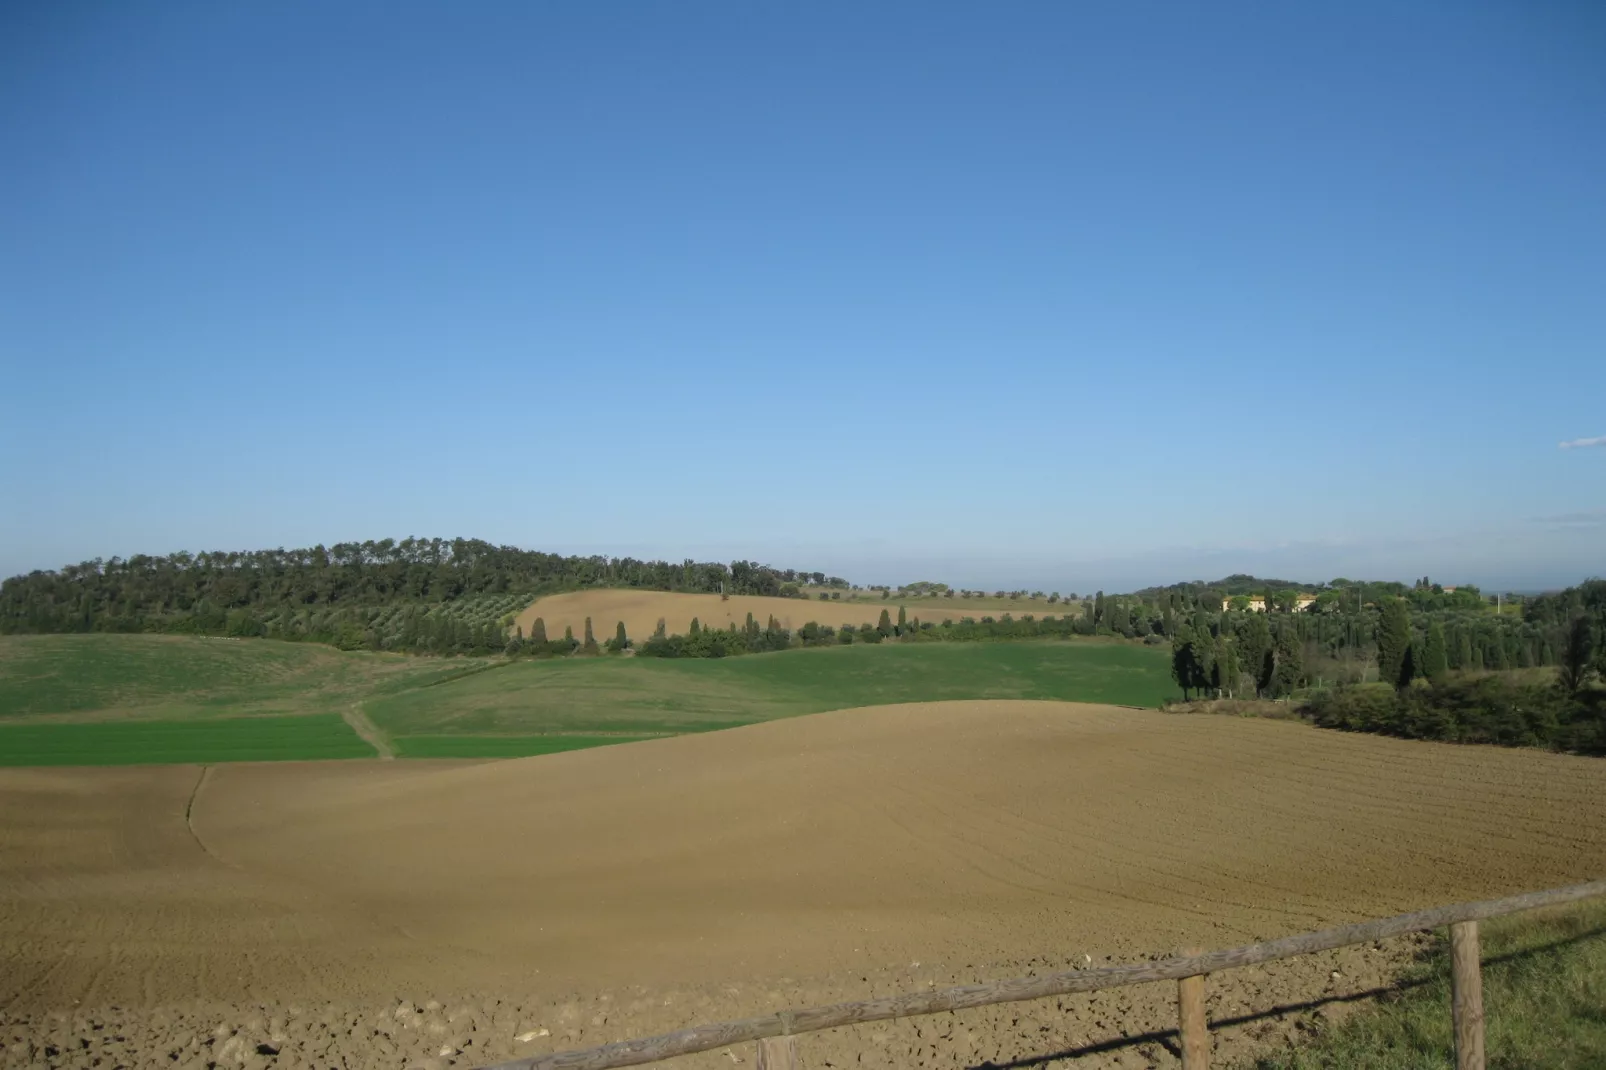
left=490, top=880, right=1606, bottom=1070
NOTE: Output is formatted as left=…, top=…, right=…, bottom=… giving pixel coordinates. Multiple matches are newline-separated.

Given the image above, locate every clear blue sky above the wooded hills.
left=0, top=2, right=1606, bottom=590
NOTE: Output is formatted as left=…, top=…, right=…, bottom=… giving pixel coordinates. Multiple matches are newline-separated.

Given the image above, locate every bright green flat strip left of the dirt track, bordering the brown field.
left=0, top=713, right=374, bottom=765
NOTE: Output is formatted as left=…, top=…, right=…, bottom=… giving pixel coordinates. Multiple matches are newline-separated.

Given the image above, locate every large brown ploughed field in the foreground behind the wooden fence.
left=0, top=700, right=1606, bottom=1070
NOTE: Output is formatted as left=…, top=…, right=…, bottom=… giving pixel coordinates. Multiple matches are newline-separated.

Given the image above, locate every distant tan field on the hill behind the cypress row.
left=516, top=588, right=976, bottom=643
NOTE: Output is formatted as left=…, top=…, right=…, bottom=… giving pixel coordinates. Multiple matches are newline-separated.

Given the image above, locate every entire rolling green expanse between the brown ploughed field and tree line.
left=0, top=635, right=1176, bottom=765
